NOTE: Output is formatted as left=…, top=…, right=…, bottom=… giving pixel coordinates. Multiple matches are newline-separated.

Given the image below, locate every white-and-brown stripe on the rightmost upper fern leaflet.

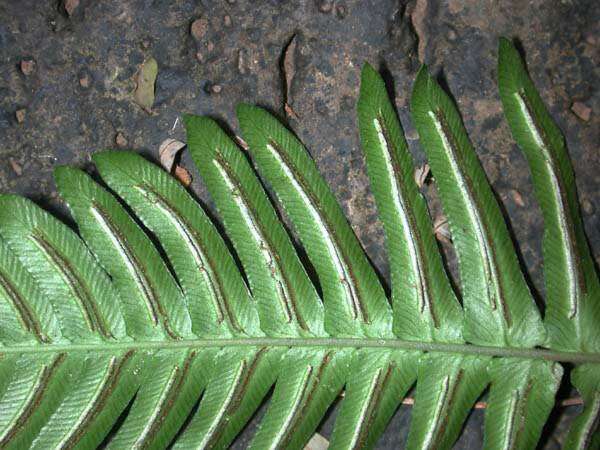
left=514, top=92, right=585, bottom=319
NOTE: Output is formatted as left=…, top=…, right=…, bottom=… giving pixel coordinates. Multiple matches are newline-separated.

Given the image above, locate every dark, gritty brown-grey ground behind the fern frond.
left=0, top=0, right=600, bottom=449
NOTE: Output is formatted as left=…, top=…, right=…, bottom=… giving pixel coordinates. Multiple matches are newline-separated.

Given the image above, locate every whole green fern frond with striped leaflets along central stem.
left=0, top=40, right=600, bottom=450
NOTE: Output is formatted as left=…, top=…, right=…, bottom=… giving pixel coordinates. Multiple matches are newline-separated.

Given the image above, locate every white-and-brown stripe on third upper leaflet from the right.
left=373, top=118, right=438, bottom=328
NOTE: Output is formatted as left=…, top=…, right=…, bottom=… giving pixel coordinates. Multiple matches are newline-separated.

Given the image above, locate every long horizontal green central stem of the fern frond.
left=0, top=337, right=600, bottom=364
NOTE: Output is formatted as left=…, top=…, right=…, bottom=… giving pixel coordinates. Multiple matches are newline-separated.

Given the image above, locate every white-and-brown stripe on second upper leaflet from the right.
left=428, top=111, right=510, bottom=328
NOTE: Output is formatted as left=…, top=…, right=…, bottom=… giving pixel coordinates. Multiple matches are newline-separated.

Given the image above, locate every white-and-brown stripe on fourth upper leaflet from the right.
left=266, top=144, right=366, bottom=322
